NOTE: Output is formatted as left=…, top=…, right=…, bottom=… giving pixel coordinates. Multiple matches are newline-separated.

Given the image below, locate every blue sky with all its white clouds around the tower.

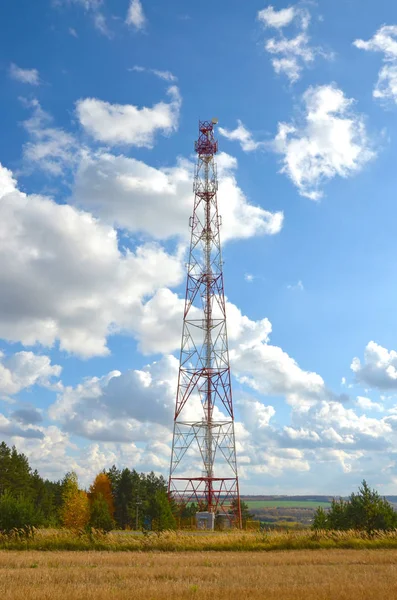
left=0, top=0, right=397, bottom=494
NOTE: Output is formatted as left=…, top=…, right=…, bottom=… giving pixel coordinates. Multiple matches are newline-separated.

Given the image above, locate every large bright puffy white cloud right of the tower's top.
left=274, top=85, right=375, bottom=200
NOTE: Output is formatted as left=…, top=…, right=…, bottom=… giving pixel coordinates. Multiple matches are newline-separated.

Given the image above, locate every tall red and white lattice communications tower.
left=169, top=119, right=241, bottom=527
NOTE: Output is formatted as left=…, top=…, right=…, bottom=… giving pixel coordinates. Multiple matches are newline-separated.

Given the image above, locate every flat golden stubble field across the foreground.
left=0, top=550, right=397, bottom=600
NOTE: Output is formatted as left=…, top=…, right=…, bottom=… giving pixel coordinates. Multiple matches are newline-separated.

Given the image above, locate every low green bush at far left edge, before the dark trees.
left=0, top=491, right=42, bottom=535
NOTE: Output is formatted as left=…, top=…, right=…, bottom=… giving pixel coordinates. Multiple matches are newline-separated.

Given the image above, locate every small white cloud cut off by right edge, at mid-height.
left=350, top=341, right=397, bottom=390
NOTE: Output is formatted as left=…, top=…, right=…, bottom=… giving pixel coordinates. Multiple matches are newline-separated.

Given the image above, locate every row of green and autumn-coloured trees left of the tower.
left=0, top=442, right=176, bottom=532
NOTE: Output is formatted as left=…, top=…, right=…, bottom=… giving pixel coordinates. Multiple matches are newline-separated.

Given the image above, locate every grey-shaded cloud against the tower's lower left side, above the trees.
left=49, top=355, right=179, bottom=442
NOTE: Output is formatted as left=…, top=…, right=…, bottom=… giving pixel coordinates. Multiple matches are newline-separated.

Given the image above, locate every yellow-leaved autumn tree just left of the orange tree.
left=61, top=472, right=90, bottom=529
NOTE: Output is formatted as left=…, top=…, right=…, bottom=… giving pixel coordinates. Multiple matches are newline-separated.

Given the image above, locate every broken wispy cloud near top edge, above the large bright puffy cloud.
left=257, top=5, right=330, bottom=83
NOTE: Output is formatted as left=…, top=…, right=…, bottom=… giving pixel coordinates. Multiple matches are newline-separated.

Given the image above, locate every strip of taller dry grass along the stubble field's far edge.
left=0, top=530, right=397, bottom=552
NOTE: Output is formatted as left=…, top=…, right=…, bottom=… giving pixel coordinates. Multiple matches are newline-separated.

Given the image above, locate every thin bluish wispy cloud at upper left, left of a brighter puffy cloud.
left=23, top=100, right=80, bottom=176
